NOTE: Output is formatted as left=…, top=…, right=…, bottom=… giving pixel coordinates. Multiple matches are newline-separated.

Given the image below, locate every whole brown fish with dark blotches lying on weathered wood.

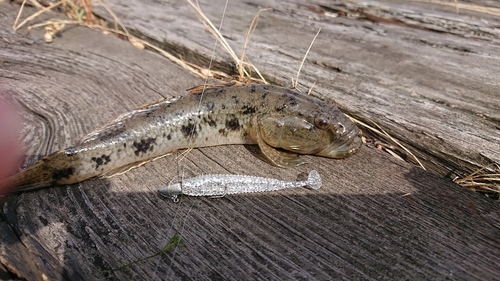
left=1, top=84, right=361, bottom=192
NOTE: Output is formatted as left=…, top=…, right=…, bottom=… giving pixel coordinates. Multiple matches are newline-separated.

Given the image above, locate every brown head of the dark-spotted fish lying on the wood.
left=254, top=96, right=361, bottom=164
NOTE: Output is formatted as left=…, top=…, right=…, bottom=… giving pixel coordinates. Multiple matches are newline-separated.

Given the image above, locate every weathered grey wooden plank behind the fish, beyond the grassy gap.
left=94, top=0, right=500, bottom=178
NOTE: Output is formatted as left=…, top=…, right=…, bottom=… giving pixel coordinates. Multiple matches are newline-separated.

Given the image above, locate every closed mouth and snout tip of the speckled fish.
left=317, top=127, right=361, bottom=158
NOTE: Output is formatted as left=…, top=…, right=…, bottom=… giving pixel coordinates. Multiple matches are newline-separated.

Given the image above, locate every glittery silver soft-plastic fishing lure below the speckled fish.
left=158, top=170, right=321, bottom=202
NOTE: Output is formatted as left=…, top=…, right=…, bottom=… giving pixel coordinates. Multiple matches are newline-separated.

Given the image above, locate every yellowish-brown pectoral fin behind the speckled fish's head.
left=248, top=116, right=306, bottom=168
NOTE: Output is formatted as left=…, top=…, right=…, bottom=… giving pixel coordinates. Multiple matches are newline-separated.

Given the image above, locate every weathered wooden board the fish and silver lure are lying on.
left=0, top=2, right=500, bottom=280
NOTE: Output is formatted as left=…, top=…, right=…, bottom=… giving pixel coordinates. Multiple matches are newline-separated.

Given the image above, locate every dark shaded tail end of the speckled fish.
left=0, top=150, right=80, bottom=194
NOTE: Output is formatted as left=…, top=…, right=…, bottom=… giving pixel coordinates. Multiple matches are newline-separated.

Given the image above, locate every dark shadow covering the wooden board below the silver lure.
left=4, top=155, right=500, bottom=280
